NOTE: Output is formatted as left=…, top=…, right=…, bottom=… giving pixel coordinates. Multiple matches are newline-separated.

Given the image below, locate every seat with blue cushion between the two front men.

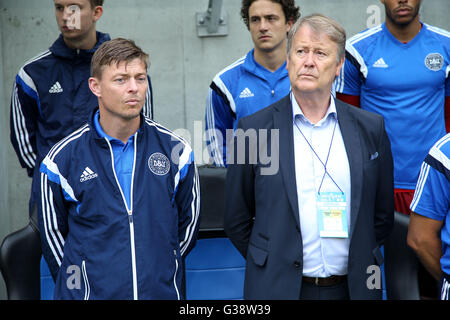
left=185, top=166, right=245, bottom=300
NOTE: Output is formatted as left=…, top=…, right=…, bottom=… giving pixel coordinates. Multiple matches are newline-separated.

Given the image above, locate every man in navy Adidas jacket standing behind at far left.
left=10, top=0, right=152, bottom=220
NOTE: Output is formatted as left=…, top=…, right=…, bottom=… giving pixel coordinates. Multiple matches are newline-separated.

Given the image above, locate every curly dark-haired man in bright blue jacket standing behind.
left=205, top=0, right=300, bottom=167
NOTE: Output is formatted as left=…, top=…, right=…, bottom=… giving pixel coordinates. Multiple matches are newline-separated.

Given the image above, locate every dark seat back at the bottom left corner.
left=0, top=222, right=41, bottom=300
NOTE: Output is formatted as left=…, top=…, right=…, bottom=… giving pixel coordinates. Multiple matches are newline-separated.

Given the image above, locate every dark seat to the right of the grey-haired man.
left=384, top=212, right=420, bottom=300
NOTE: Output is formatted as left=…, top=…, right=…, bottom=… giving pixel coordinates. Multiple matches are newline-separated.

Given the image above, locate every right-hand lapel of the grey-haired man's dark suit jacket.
left=335, top=100, right=363, bottom=239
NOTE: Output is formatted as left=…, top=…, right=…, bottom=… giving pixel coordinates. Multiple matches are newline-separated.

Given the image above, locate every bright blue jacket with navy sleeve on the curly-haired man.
left=205, top=49, right=291, bottom=167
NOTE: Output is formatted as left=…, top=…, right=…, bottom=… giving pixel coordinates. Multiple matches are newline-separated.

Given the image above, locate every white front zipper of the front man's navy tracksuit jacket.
left=105, top=133, right=138, bottom=300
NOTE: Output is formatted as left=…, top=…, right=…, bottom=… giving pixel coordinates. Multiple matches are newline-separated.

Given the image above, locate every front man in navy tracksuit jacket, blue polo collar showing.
left=38, top=39, right=200, bottom=299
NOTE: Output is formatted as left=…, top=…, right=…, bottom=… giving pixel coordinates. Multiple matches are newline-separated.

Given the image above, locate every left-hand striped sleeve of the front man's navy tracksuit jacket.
left=38, top=157, right=70, bottom=279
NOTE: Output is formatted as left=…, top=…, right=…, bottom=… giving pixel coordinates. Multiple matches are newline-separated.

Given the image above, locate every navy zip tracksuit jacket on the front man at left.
left=38, top=112, right=200, bottom=299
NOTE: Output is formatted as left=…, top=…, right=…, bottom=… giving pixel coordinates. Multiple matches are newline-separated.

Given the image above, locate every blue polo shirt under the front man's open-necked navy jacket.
left=94, top=111, right=134, bottom=208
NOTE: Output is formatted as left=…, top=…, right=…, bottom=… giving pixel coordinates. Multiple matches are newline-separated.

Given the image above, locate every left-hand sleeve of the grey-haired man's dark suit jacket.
left=224, top=119, right=255, bottom=258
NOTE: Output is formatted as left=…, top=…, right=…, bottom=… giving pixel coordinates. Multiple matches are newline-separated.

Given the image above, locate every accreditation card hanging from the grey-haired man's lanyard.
left=317, top=192, right=348, bottom=238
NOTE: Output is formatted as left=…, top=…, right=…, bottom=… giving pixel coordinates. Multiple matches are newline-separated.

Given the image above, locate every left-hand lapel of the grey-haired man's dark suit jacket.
left=273, top=95, right=300, bottom=228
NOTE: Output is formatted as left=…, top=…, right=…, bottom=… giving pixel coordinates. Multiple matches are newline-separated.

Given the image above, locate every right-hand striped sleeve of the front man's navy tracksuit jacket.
left=174, top=144, right=200, bottom=257
